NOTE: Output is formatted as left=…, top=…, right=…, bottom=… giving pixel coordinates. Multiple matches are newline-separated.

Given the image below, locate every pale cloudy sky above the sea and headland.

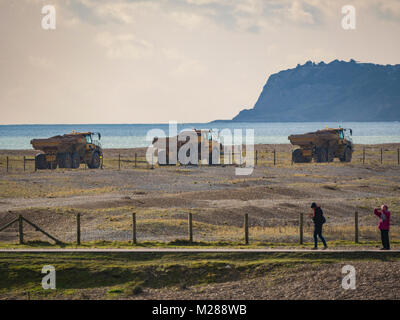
left=0, top=0, right=400, bottom=124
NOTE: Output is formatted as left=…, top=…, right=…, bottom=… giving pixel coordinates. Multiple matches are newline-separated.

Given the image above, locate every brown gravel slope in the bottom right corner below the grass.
left=131, top=262, right=400, bottom=300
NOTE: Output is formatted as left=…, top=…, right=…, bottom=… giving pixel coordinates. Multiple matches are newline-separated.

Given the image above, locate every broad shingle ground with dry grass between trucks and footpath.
left=0, top=145, right=400, bottom=241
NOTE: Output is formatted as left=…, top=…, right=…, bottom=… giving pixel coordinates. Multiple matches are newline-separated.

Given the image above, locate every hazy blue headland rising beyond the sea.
left=232, top=60, right=400, bottom=121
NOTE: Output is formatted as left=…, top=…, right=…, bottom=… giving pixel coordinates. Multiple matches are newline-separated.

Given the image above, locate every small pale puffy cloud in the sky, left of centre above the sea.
left=95, top=31, right=153, bottom=59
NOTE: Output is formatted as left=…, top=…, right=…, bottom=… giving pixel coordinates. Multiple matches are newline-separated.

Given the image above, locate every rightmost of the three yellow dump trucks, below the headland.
left=288, top=128, right=353, bottom=163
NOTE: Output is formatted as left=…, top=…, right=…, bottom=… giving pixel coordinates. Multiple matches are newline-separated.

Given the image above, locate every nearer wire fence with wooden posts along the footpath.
left=0, top=211, right=400, bottom=245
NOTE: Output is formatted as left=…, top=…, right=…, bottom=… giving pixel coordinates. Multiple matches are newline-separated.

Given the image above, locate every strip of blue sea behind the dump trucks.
left=0, top=122, right=400, bottom=149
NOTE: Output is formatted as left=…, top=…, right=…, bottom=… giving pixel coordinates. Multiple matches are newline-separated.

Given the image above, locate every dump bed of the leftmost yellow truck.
left=31, top=134, right=86, bottom=152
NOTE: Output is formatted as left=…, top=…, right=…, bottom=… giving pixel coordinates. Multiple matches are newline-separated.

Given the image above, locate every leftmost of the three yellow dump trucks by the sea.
left=31, top=132, right=103, bottom=170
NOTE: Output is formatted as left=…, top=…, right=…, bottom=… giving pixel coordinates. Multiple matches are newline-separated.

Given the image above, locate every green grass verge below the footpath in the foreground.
left=0, top=252, right=400, bottom=299
